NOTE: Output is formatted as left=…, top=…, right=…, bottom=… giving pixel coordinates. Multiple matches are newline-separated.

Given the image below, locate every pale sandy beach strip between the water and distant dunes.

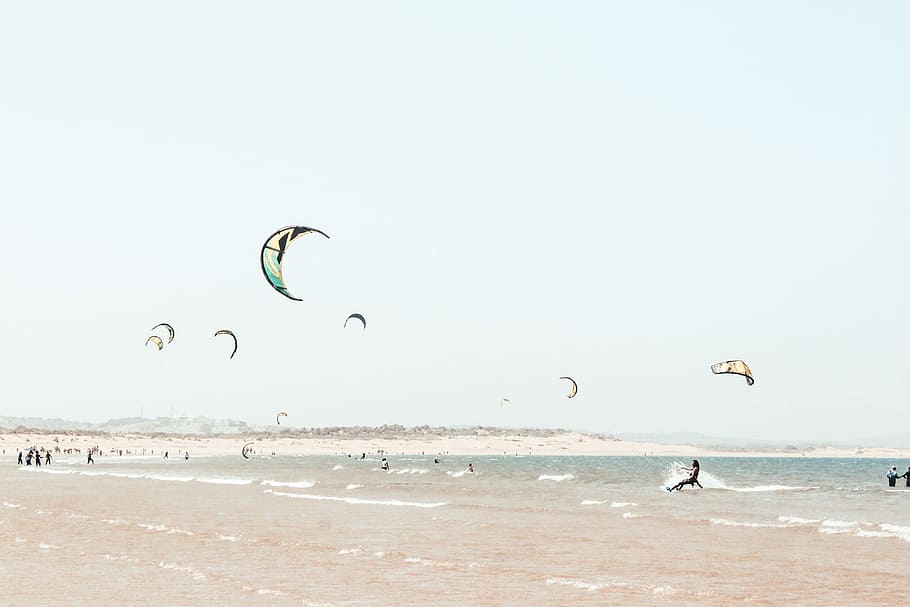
left=0, top=430, right=910, bottom=460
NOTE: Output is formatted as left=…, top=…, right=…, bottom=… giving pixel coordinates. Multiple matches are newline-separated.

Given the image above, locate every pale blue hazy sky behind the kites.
left=0, top=1, right=910, bottom=439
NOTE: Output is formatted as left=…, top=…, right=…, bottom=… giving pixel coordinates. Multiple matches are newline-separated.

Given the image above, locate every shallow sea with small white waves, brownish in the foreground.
left=0, top=455, right=910, bottom=606
